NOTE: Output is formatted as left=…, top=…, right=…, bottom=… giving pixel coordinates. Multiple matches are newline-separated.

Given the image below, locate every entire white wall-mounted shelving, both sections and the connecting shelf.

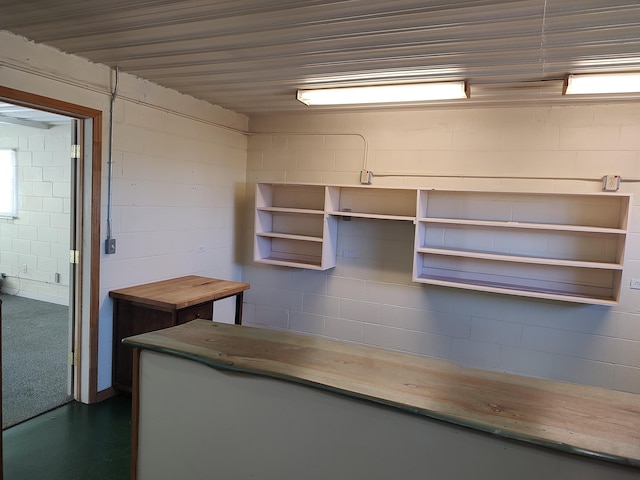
left=254, top=183, right=631, bottom=305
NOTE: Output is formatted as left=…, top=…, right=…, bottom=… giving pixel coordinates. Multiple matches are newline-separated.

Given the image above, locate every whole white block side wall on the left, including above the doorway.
left=0, top=32, right=248, bottom=395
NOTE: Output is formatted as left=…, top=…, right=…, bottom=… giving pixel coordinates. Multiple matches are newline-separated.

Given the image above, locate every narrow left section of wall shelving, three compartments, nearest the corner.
left=254, top=183, right=338, bottom=270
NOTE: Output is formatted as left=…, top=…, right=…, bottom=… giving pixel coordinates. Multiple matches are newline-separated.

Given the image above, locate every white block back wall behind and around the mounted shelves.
left=243, top=108, right=640, bottom=393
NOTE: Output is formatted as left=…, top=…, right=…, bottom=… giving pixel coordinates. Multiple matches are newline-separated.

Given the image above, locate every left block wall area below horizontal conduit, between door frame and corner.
left=99, top=81, right=247, bottom=388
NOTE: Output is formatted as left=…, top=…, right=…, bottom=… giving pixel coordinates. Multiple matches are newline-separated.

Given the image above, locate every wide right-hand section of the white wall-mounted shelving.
left=413, top=190, right=630, bottom=305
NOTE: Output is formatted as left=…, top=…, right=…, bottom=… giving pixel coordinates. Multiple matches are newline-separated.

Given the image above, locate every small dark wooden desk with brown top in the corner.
left=109, top=275, right=249, bottom=391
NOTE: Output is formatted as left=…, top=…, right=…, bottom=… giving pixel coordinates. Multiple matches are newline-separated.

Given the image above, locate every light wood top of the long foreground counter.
left=124, top=320, right=640, bottom=468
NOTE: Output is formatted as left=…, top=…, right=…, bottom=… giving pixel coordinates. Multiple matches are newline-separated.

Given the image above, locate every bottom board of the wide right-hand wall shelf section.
left=414, top=275, right=618, bottom=305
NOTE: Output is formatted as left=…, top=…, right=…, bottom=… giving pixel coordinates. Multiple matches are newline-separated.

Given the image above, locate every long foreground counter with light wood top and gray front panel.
left=124, top=320, right=640, bottom=480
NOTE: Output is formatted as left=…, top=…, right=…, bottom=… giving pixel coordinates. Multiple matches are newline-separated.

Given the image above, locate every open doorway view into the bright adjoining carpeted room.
left=0, top=102, right=78, bottom=429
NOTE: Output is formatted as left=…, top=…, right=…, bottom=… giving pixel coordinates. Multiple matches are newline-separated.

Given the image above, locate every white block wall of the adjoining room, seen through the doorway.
left=0, top=122, right=71, bottom=305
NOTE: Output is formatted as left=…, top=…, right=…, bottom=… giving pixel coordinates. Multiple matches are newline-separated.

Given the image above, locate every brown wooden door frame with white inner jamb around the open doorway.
left=0, top=86, right=102, bottom=403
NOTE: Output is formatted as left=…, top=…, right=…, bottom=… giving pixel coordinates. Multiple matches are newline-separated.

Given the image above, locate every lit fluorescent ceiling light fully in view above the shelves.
left=296, top=81, right=469, bottom=105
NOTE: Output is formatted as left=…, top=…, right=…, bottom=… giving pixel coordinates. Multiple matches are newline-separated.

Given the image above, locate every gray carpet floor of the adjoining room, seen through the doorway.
left=0, top=294, right=71, bottom=429
